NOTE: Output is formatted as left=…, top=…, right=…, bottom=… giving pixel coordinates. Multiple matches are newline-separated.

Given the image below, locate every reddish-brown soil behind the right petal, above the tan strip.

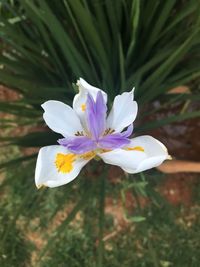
left=140, top=97, right=200, bottom=161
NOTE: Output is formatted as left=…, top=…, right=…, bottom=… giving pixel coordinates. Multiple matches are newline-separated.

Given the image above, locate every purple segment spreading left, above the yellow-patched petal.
left=58, top=136, right=97, bottom=154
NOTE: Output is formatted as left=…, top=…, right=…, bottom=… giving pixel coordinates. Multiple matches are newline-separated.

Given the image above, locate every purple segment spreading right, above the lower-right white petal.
left=98, top=133, right=131, bottom=149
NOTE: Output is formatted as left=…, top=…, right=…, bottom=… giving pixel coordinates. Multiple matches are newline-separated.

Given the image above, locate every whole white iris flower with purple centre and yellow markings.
left=35, top=78, right=169, bottom=188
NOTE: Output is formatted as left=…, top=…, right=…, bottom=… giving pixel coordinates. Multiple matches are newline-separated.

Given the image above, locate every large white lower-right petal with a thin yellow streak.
left=99, top=135, right=169, bottom=173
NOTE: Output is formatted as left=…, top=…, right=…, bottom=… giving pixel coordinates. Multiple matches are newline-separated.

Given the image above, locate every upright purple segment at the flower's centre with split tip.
left=86, top=91, right=107, bottom=141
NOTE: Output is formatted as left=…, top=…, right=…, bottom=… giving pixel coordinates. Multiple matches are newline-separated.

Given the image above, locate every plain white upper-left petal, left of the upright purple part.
left=42, top=100, right=83, bottom=137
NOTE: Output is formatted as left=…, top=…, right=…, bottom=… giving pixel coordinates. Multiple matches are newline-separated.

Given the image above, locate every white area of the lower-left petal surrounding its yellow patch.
left=35, top=146, right=89, bottom=188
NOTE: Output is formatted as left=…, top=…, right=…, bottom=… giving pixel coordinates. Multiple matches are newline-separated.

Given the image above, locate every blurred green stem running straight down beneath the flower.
left=97, top=171, right=106, bottom=267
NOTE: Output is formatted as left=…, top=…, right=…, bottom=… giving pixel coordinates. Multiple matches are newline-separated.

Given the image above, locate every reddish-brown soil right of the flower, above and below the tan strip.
left=140, top=98, right=200, bottom=206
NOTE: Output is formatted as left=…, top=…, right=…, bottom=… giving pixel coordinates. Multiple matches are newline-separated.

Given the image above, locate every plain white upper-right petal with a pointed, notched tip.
left=107, top=89, right=138, bottom=132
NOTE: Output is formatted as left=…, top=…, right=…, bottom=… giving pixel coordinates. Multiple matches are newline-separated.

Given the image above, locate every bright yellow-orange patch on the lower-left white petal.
left=55, top=153, right=76, bottom=173
